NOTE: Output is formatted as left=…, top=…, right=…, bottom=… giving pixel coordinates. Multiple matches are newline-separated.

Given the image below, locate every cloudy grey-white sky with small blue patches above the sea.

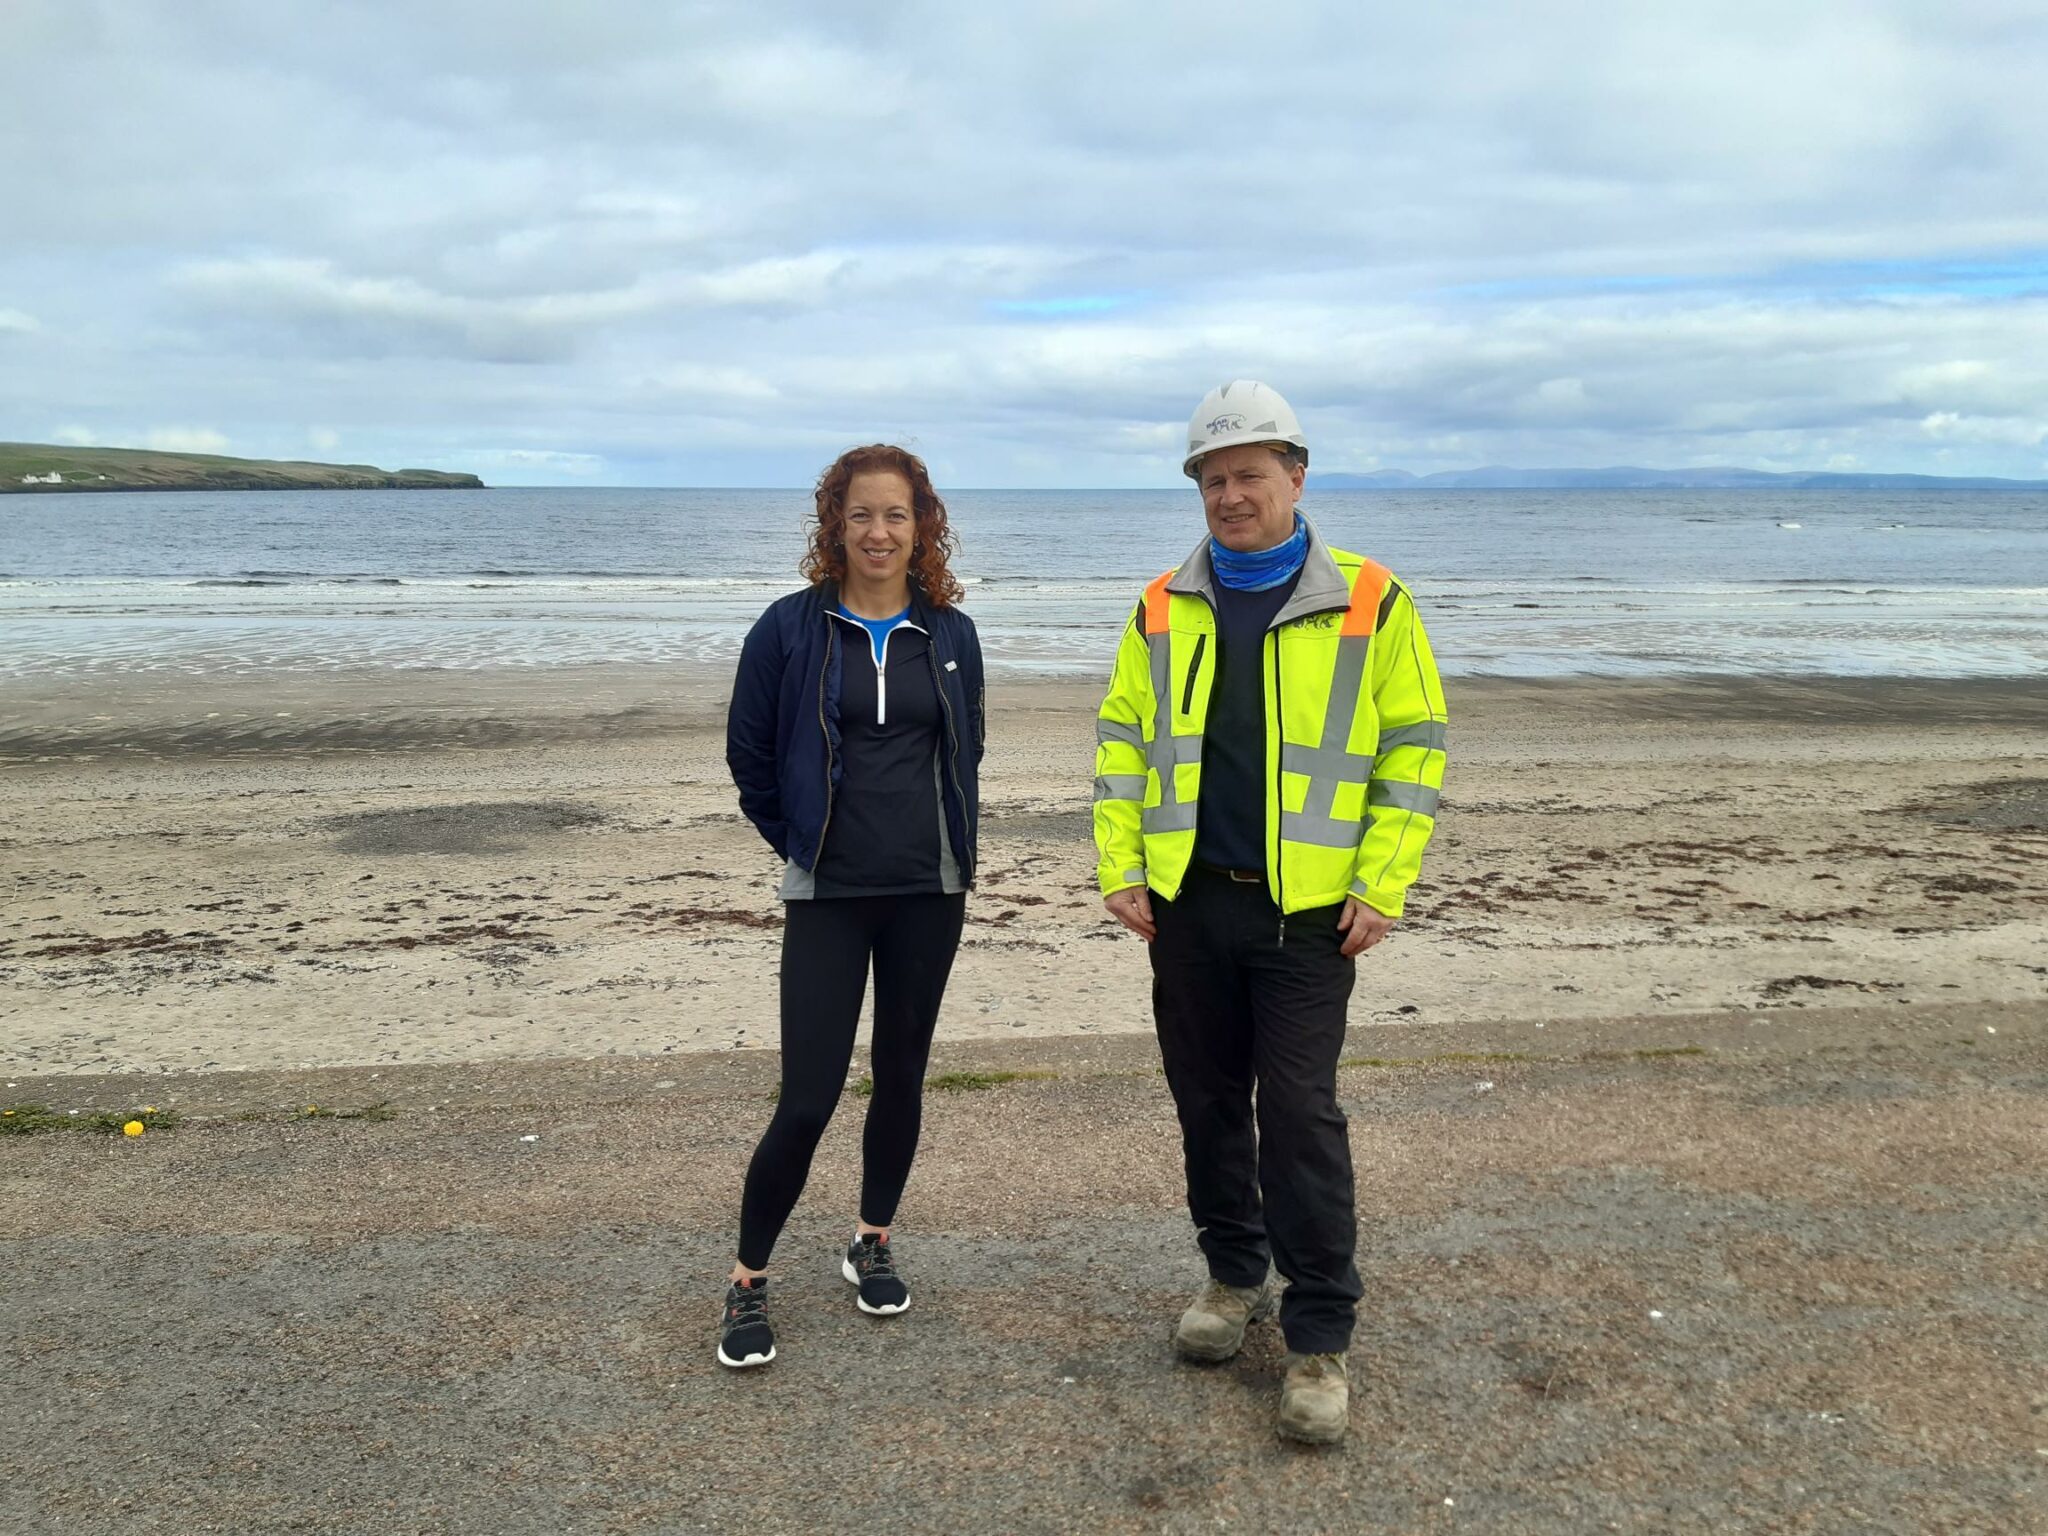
left=0, top=0, right=2048, bottom=485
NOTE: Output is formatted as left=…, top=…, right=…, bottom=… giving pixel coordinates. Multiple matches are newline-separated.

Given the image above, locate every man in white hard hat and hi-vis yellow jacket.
left=1096, top=379, right=1446, bottom=1444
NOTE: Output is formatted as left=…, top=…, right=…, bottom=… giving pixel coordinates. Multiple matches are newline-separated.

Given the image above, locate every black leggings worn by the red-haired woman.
left=739, top=895, right=967, bottom=1270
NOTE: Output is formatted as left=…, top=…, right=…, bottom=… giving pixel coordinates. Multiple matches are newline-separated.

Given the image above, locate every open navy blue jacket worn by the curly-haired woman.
left=725, top=582, right=987, bottom=885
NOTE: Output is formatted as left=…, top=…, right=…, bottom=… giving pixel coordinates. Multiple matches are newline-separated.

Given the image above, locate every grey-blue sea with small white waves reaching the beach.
left=0, top=487, right=2048, bottom=686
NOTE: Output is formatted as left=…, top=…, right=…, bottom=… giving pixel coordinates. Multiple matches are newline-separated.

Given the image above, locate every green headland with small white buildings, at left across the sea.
left=0, top=442, right=483, bottom=492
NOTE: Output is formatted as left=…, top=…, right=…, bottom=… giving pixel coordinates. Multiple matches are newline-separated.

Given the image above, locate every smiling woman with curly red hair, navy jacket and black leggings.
left=719, top=444, right=983, bottom=1368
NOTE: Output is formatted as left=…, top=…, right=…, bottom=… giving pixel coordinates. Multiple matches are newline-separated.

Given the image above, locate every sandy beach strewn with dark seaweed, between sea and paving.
left=0, top=666, right=2048, bottom=1075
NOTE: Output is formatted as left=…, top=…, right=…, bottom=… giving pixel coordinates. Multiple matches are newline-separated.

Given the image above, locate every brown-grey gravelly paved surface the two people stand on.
left=0, top=1004, right=2048, bottom=1536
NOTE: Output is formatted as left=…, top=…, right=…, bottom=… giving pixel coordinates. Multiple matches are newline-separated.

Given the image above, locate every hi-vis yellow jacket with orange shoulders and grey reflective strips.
left=1096, top=524, right=1448, bottom=918
